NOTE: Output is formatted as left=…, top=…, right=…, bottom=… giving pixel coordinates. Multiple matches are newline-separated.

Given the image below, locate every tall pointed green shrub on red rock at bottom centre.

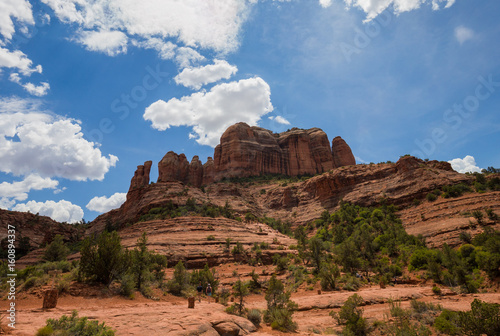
left=264, top=274, right=298, bottom=332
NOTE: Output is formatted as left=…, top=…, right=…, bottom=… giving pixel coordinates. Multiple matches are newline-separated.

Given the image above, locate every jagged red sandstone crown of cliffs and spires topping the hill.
left=130, top=123, right=356, bottom=190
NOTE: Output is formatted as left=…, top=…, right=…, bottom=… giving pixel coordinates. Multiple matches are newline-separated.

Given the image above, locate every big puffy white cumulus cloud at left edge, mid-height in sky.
left=0, top=98, right=118, bottom=181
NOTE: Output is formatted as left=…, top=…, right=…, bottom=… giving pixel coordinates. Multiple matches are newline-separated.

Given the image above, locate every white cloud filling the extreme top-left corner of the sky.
left=0, top=0, right=35, bottom=40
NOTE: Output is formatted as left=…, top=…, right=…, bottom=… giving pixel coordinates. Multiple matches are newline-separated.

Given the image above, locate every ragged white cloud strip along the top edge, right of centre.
left=344, top=0, right=455, bottom=21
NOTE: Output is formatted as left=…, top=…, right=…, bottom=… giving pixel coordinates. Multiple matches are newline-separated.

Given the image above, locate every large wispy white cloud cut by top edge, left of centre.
left=42, top=0, right=255, bottom=57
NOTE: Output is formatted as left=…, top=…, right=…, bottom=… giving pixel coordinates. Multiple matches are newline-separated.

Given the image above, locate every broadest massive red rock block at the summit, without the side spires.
left=214, top=123, right=338, bottom=181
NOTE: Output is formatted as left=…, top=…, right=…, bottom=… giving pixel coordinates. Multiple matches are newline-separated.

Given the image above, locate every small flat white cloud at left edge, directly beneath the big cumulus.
left=0, top=174, right=59, bottom=201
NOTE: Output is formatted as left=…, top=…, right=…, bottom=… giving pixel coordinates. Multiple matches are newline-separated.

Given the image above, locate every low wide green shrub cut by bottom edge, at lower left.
left=36, top=310, right=115, bottom=336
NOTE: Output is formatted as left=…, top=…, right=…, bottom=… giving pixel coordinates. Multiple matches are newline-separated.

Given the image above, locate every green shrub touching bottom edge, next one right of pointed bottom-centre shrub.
left=330, top=294, right=370, bottom=336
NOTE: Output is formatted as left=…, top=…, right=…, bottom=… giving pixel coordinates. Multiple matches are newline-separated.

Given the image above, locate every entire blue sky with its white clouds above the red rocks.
left=0, top=0, right=500, bottom=222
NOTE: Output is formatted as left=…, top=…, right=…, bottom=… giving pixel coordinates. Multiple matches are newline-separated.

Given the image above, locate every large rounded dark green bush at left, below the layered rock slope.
left=78, top=231, right=130, bottom=285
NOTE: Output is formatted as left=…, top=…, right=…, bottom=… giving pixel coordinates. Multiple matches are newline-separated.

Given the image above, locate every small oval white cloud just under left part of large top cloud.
left=76, top=30, right=128, bottom=56
